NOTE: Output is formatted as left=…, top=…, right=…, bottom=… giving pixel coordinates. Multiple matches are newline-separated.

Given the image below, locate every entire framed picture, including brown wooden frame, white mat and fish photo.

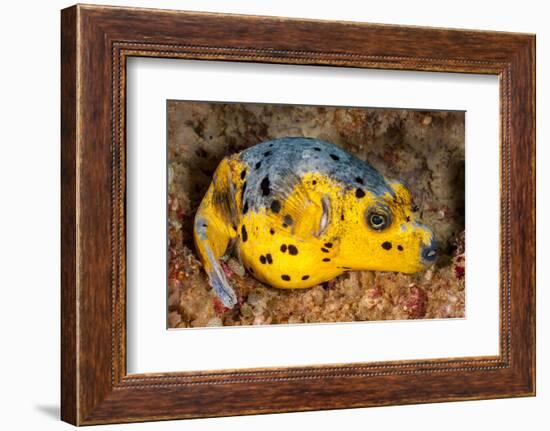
left=61, top=5, right=535, bottom=425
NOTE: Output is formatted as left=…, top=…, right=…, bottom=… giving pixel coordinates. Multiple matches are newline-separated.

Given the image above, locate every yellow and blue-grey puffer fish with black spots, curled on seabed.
left=194, top=137, right=437, bottom=308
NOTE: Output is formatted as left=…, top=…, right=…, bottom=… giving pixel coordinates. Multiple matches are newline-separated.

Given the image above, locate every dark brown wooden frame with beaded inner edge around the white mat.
left=61, top=5, right=535, bottom=425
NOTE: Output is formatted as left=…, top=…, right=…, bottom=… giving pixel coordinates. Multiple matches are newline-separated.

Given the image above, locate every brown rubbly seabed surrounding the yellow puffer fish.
left=168, top=101, right=465, bottom=328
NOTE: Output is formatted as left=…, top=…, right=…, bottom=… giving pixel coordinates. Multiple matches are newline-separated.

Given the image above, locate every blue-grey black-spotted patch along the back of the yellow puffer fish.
left=240, top=137, right=394, bottom=211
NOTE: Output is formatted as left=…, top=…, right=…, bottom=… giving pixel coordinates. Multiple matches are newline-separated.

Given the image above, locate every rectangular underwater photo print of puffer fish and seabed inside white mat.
left=168, top=102, right=465, bottom=328
